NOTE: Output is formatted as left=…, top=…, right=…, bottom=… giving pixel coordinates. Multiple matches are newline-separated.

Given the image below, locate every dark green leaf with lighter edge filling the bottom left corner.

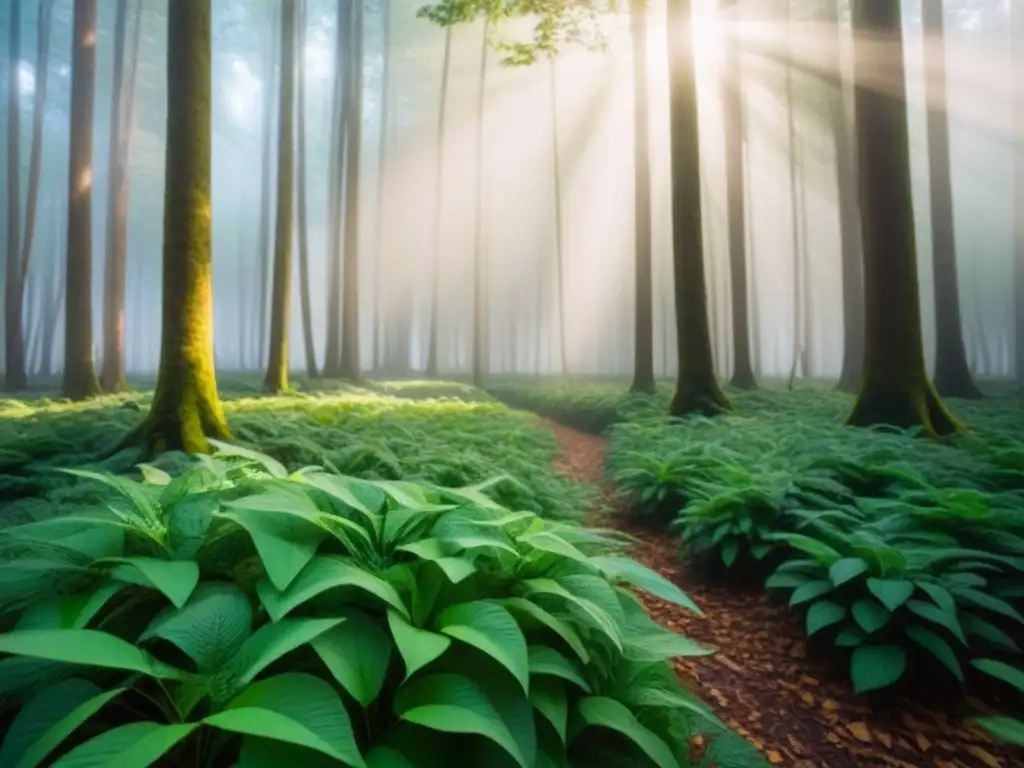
left=0, top=678, right=126, bottom=768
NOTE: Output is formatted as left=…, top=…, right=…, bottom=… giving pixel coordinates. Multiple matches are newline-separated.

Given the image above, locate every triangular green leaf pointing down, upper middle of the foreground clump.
left=217, top=509, right=328, bottom=590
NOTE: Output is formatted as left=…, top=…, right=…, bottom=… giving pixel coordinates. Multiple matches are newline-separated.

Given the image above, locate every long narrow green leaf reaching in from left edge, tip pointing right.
left=0, top=630, right=181, bottom=680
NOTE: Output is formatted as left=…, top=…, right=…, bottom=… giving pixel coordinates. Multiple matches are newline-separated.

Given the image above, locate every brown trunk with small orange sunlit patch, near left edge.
left=61, top=0, right=99, bottom=400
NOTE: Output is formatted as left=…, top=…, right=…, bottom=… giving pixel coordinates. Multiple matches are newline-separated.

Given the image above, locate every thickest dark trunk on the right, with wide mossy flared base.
left=848, top=0, right=958, bottom=435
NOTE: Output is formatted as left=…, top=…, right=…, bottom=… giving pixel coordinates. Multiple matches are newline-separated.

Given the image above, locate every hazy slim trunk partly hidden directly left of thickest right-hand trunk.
left=822, top=0, right=864, bottom=392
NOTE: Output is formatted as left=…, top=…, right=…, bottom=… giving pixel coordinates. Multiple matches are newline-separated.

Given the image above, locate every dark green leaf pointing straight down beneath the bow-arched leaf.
left=312, top=610, right=391, bottom=709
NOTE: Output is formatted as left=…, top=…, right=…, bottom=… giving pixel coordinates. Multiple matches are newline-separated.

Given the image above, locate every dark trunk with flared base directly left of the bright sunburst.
left=667, top=0, right=729, bottom=416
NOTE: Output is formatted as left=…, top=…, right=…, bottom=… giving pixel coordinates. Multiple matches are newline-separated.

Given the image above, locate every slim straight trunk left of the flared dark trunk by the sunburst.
left=630, top=0, right=654, bottom=393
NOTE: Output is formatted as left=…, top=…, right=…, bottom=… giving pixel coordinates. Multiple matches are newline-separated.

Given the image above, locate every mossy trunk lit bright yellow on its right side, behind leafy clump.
left=127, top=0, right=230, bottom=458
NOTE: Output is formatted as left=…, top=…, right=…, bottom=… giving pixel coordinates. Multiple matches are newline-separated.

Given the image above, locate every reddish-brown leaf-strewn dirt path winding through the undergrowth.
left=546, top=422, right=1024, bottom=768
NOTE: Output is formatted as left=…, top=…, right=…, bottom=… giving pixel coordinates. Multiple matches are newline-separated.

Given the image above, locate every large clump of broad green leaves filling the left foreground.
left=0, top=442, right=763, bottom=768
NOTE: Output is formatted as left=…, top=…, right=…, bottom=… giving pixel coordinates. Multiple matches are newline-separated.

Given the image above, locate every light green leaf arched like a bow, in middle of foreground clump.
left=256, top=556, right=409, bottom=622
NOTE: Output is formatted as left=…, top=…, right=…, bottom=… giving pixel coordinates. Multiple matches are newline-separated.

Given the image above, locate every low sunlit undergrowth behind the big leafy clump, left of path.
left=0, top=379, right=593, bottom=525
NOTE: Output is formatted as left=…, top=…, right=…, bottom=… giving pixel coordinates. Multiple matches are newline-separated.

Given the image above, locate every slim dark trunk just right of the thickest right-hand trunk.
left=922, top=0, right=981, bottom=398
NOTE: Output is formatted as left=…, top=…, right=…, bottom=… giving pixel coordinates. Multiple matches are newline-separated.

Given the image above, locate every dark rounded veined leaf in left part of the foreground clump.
left=139, top=583, right=253, bottom=671
